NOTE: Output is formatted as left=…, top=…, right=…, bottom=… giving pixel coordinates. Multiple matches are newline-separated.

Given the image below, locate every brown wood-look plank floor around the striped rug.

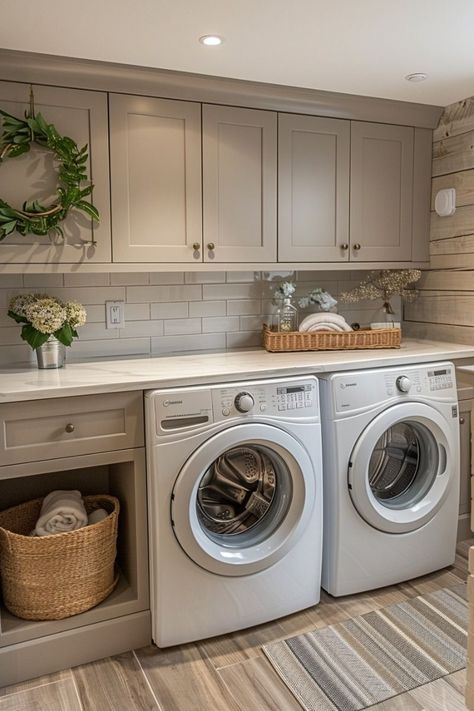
left=0, top=540, right=474, bottom=711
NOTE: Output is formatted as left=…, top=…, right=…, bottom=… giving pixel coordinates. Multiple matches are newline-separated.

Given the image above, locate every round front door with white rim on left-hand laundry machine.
left=171, top=423, right=320, bottom=576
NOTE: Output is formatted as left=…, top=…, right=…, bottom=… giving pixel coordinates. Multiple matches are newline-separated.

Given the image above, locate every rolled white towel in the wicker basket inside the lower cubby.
left=34, top=490, right=87, bottom=536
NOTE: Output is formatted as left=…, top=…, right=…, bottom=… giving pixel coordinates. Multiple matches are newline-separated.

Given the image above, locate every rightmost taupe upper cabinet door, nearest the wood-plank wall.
left=350, top=121, right=413, bottom=262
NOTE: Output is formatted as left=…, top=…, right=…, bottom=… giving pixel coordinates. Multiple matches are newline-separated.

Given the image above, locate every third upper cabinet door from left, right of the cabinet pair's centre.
left=203, top=106, right=277, bottom=262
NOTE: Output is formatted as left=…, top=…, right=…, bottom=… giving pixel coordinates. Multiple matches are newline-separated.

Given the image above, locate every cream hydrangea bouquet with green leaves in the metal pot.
left=8, top=294, right=87, bottom=349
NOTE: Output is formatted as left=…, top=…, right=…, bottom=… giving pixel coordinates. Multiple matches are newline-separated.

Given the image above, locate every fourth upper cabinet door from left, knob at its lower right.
left=278, top=114, right=350, bottom=262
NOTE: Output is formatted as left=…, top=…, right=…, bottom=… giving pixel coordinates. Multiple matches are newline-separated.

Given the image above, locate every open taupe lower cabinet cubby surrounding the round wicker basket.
left=0, top=393, right=151, bottom=686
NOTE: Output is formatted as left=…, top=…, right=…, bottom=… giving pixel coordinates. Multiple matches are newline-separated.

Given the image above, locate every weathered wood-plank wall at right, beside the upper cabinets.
left=404, top=97, right=474, bottom=344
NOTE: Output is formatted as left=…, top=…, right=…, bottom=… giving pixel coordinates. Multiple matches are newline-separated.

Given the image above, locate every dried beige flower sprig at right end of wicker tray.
left=339, top=269, right=421, bottom=314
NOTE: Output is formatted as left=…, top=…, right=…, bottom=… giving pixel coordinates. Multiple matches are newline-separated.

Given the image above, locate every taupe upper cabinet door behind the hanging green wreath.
left=0, top=82, right=111, bottom=264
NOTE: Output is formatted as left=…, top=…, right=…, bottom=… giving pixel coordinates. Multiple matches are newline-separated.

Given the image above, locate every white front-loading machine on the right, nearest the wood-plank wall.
left=320, top=363, right=459, bottom=596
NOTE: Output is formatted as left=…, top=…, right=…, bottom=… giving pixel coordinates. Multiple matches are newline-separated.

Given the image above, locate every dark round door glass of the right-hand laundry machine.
left=368, top=420, right=439, bottom=509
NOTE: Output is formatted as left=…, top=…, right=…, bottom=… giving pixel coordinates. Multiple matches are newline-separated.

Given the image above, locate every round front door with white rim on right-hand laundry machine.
left=348, top=402, right=456, bottom=533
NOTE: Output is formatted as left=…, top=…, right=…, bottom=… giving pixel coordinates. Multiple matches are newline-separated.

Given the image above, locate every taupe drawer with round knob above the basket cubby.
left=0, top=392, right=144, bottom=465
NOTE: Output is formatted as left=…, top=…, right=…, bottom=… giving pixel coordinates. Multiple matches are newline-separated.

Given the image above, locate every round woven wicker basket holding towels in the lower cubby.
left=0, top=495, right=120, bottom=620
